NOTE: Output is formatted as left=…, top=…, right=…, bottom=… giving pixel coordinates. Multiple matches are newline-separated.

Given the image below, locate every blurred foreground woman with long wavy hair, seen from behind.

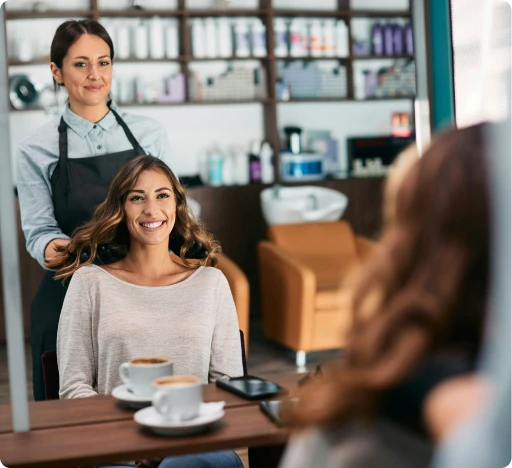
left=282, top=126, right=491, bottom=468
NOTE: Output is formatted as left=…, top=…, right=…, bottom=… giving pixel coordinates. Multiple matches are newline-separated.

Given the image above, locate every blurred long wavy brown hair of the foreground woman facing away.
left=289, top=125, right=491, bottom=426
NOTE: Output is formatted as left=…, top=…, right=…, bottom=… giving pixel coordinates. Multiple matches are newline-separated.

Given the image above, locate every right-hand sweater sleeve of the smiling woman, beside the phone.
left=208, top=271, right=243, bottom=382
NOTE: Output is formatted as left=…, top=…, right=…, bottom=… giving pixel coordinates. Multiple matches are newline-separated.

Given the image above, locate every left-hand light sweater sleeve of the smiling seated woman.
left=57, top=272, right=98, bottom=399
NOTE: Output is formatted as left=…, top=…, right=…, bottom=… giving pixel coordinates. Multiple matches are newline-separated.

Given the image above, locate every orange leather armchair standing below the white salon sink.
left=258, top=221, right=373, bottom=366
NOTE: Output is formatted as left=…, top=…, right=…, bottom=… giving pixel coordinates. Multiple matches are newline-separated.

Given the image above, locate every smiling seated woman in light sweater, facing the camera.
left=49, top=156, right=243, bottom=467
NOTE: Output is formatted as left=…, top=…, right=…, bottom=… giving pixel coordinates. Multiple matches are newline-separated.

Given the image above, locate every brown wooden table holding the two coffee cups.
left=0, top=374, right=300, bottom=468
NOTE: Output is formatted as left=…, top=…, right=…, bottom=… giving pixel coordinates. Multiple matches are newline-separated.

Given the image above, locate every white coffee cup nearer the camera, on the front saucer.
left=153, top=375, right=203, bottom=422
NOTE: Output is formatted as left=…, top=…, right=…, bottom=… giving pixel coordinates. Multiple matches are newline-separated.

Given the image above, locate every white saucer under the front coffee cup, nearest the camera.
left=133, top=401, right=225, bottom=436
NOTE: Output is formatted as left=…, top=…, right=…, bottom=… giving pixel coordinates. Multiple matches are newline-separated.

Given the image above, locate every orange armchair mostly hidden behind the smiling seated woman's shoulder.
left=217, top=254, right=249, bottom=353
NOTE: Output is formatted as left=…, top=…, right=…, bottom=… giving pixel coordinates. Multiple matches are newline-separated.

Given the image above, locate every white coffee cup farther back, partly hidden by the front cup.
left=119, top=357, right=173, bottom=398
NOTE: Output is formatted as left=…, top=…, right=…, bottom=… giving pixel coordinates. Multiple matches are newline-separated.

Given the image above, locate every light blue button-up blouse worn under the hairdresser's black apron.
left=16, top=103, right=173, bottom=267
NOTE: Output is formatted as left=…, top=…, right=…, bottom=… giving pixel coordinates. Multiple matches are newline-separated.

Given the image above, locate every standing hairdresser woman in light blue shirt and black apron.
left=17, top=20, right=174, bottom=400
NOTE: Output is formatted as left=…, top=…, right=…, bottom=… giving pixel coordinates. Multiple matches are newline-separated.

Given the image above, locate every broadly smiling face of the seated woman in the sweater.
left=124, top=170, right=176, bottom=249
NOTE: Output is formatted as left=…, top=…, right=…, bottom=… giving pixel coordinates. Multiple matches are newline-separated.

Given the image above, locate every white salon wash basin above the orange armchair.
left=260, top=185, right=348, bottom=226
